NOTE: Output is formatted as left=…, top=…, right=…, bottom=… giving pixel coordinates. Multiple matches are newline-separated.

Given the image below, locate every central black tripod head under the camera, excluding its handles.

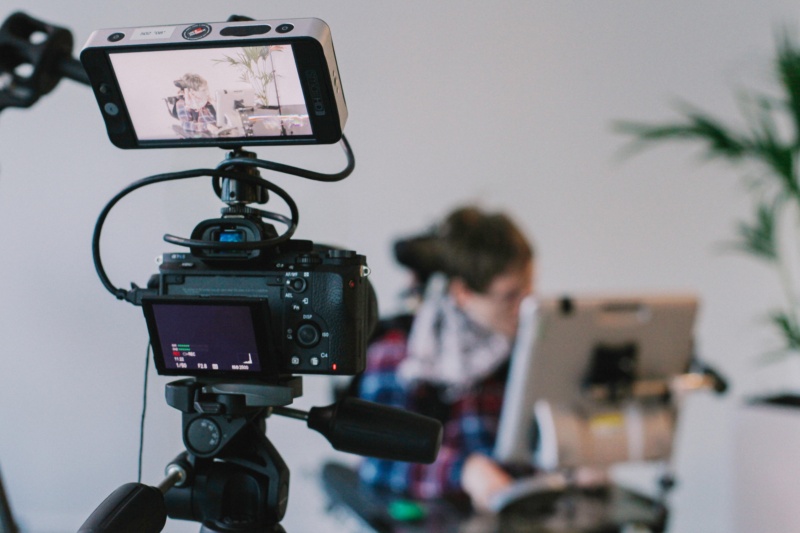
left=165, top=377, right=302, bottom=533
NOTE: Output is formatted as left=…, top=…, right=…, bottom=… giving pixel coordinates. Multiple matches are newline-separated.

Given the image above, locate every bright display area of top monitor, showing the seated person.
left=109, top=44, right=314, bottom=143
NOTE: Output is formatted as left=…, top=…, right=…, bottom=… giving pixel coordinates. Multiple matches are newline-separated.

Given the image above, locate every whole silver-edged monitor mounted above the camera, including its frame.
left=80, top=19, right=347, bottom=148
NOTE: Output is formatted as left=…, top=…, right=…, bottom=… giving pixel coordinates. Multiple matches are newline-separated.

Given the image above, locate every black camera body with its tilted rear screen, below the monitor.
left=142, top=237, right=376, bottom=380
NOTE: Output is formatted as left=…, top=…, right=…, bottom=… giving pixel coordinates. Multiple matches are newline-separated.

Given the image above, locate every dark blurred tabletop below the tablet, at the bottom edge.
left=322, top=463, right=663, bottom=533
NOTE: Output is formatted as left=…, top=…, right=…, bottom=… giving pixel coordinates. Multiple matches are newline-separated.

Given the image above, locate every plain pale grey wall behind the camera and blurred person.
left=0, top=0, right=798, bottom=533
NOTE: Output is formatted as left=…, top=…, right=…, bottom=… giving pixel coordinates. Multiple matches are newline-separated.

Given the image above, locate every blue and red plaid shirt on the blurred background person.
left=359, top=329, right=508, bottom=499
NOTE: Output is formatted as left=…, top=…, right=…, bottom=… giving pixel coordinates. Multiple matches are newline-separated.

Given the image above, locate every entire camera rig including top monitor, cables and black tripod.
left=73, top=16, right=442, bottom=533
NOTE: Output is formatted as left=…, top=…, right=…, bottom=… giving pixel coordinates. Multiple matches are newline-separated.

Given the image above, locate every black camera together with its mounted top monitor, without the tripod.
left=80, top=19, right=376, bottom=382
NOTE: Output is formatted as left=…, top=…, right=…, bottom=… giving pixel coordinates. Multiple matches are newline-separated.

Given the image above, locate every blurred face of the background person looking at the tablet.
left=450, top=261, right=534, bottom=337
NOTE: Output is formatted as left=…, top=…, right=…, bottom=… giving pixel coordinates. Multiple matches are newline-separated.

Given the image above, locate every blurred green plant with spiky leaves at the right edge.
left=615, top=33, right=800, bottom=403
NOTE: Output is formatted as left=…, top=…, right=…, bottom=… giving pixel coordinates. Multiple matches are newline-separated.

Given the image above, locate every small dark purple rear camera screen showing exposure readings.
left=142, top=297, right=272, bottom=377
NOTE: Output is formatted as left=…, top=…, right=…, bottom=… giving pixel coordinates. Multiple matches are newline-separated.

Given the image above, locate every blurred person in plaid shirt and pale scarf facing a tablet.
left=359, top=206, right=534, bottom=509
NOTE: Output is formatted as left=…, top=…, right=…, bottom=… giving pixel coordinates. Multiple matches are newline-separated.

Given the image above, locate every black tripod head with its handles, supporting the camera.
left=79, top=376, right=442, bottom=533
